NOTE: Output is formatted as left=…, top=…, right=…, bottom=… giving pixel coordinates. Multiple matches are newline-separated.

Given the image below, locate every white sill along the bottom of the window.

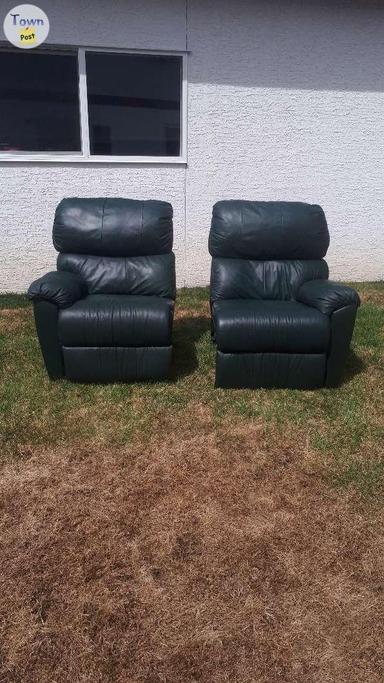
left=0, top=153, right=187, bottom=165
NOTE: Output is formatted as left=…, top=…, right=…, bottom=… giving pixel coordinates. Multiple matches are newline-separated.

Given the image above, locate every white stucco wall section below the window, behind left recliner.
left=0, top=164, right=185, bottom=292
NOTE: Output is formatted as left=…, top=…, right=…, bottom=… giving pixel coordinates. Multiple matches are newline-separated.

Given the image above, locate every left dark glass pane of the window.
left=0, top=50, right=81, bottom=152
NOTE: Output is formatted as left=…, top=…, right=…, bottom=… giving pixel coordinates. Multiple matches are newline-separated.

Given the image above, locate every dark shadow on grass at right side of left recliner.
left=169, top=316, right=211, bottom=382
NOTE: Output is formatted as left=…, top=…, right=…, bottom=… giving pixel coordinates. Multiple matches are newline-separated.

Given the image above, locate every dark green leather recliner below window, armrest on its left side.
left=28, top=198, right=176, bottom=382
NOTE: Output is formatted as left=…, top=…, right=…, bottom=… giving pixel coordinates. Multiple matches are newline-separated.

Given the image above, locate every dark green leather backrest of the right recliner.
left=209, top=200, right=329, bottom=301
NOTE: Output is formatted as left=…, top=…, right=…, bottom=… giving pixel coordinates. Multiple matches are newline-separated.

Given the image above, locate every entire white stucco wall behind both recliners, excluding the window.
left=0, top=0, right=384, bottom=291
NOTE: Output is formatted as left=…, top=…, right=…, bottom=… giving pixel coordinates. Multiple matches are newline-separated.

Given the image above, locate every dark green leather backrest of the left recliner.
left=53, top=197, right=175, bottom=298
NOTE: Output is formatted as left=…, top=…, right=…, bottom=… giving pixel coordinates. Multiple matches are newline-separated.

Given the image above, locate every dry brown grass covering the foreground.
left=0, top=412, right=384, bottom=683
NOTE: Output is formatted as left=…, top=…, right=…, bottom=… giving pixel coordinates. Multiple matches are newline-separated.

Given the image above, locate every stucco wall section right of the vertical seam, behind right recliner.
left=187, top=0, right=384, bottom=282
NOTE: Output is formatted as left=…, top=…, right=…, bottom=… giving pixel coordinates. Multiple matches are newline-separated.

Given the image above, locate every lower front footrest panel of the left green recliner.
left=62, top=346, right=172, bottom=383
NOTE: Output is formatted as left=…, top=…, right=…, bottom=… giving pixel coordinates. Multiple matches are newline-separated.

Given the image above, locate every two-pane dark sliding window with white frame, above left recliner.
left=0, top=48, right=185, bottom=161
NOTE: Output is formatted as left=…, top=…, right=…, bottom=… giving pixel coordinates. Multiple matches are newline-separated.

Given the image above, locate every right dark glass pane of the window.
left=86, top=52, right=182, bottom=156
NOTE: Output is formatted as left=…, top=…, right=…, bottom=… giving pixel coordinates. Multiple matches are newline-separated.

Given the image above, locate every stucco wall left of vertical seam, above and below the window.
left=0, top=0, right=186, bottom=291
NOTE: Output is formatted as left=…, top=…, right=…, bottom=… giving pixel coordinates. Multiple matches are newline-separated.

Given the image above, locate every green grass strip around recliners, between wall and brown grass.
left=0, top=283, right=384, bottom=495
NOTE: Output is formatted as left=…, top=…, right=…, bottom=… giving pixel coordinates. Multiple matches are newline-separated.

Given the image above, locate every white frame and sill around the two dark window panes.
left=0, top=45, right=187, bottom=164
